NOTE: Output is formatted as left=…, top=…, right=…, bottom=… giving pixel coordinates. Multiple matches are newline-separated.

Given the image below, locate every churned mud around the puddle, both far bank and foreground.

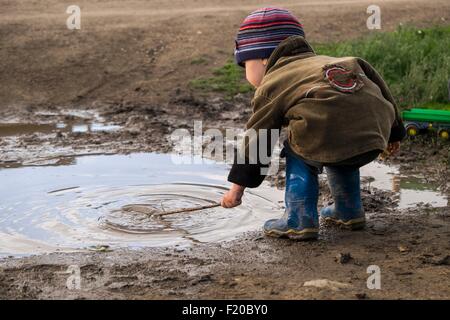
left=0, top=93, right=450, bottom=299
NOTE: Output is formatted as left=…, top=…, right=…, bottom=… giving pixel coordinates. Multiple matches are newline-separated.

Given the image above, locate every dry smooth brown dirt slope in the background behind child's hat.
left=0, top=0, right=450, bottom=108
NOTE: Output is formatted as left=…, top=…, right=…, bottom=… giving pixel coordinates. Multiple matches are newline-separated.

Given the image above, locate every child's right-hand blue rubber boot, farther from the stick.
left=320, top=166, right=365, bottom=230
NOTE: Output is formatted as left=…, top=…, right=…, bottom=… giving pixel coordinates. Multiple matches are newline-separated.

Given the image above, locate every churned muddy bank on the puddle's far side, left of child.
left=0, top=93, right=251, bottom=167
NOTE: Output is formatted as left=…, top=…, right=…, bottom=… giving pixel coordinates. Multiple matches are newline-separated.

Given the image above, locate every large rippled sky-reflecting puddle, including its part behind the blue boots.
left=0, top=153, right=448, bottom=256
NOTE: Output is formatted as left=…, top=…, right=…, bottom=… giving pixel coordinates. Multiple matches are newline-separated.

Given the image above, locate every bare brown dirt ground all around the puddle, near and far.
left=0, top=0, right=450, bottom=299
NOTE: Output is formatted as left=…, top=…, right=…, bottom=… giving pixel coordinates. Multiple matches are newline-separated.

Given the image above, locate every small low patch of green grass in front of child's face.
left=190, top=61, right=253, bottom=98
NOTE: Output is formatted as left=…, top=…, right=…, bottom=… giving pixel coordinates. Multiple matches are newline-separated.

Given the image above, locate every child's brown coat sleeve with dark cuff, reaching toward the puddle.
left=228, top=95, right=284, bottom=188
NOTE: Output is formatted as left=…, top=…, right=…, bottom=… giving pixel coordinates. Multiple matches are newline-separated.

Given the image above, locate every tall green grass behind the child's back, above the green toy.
left=314, top=26, right=450, bottom=110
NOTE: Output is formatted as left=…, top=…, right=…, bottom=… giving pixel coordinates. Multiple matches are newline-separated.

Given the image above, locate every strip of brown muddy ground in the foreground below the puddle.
left=0, top=209, right=450, bottom=299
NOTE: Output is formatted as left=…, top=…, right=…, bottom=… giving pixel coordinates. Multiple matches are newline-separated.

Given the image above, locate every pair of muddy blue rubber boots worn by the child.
left=264, top=149, right=376, bottom=240
